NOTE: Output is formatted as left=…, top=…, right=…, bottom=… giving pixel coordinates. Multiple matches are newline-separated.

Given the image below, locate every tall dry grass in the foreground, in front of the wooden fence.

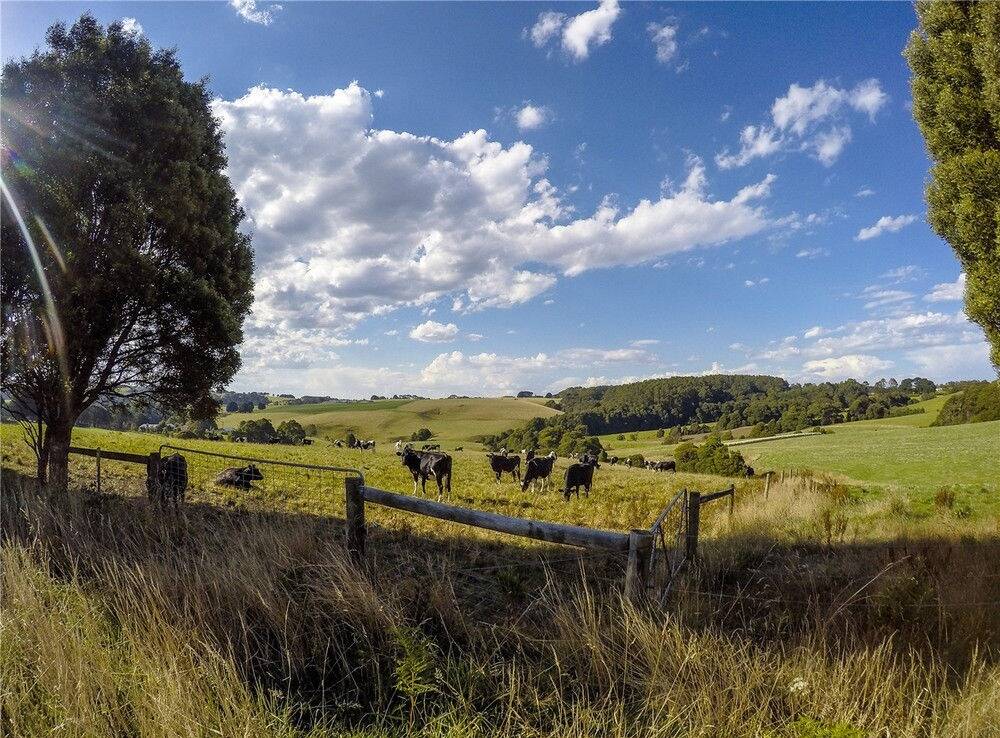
left=0, top=477, right=1000, bottom=738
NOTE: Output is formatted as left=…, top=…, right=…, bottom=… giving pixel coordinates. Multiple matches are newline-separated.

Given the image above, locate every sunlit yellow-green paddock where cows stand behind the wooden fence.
left=0, top=425, right=736, bottom=542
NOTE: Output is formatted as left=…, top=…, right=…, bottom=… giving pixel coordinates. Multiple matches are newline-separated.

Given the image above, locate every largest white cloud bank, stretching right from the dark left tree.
left=213, top=83, right=774, bottom=356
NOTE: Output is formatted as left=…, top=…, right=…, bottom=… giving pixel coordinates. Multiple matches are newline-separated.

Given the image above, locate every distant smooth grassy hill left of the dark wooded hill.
left=219, top=397, right=558, bottom=443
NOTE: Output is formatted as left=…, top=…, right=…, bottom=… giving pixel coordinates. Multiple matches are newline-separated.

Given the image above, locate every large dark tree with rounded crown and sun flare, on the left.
left=0, top=15, right=253, bottom=489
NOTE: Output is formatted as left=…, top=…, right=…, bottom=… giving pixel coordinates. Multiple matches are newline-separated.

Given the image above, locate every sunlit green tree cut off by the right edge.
left=906, top=1, right=1000, bottom=369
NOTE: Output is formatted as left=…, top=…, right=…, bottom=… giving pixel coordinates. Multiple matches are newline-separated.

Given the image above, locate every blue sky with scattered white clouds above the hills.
left=0, top=0, right=993, bottom=396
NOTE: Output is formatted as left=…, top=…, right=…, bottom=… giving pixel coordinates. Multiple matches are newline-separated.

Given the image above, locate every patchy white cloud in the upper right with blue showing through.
left=715, top=79, right=888, bottom=169
